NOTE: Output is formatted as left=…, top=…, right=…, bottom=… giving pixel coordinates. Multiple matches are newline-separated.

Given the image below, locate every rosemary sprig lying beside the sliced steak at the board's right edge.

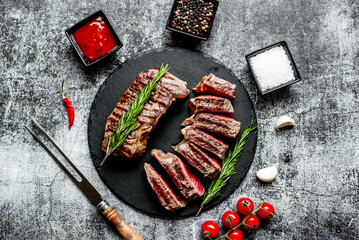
left=196, top=119, right=258, bottom=216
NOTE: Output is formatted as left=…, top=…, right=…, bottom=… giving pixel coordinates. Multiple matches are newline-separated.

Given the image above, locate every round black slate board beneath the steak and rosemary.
left=88, top=48, right=257, bottom=217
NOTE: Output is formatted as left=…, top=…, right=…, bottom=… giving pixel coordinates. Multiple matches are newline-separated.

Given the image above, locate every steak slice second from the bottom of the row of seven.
left=151, top=149, right=204, bottom=200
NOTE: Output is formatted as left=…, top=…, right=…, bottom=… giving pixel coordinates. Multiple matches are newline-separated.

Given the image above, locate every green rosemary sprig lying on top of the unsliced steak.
left=100, top=64, right=170, bottom=165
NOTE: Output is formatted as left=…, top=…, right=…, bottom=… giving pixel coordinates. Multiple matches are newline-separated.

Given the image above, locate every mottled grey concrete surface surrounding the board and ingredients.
left=0, top=0, right=359, bottom=240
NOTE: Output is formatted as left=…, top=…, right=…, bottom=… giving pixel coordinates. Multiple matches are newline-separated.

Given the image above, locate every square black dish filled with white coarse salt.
left=246, top=41, right=301, bottom=94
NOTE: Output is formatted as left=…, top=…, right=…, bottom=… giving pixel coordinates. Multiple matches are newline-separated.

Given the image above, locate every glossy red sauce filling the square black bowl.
left=73, top=17, right=117, bottom=62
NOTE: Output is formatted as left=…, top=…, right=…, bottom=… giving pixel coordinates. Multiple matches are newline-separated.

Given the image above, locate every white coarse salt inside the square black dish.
left=249, top=46, right=296, bottom=94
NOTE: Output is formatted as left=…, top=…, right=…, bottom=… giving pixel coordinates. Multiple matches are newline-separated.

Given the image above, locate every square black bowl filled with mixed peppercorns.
left=166, top=0, right=219, bottom=40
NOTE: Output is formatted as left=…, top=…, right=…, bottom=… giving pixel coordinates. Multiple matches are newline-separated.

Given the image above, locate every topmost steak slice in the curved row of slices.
left=193, top=73, right=237, bottom=99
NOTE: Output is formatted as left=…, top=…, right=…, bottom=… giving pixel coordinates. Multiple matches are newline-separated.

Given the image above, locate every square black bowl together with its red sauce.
left=65, top=10, right=123, bottom=66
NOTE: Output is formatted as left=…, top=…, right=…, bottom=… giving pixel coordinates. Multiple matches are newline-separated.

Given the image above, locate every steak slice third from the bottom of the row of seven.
left=173, top=140, right=221, bottom=179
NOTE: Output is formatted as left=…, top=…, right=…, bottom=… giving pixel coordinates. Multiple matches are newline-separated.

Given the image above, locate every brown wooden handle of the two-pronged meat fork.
left=98, top=201, right=143, bottom=240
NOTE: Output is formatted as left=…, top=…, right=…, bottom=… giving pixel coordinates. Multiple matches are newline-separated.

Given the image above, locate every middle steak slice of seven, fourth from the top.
left=181, top=126, right=228, bottom=160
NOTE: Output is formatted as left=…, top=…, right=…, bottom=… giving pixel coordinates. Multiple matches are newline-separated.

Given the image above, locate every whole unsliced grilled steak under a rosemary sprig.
left=102, top=68, right=189, bottom=158
